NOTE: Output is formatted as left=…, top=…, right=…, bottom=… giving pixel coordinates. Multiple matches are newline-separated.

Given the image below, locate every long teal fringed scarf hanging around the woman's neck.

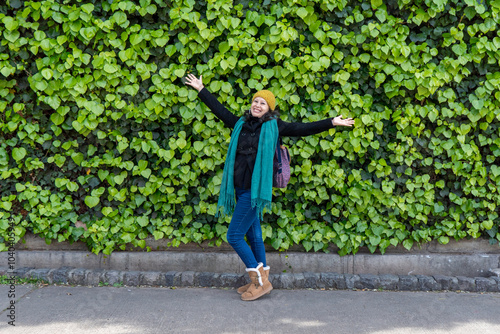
left=215, top=117, right=279, bottom=219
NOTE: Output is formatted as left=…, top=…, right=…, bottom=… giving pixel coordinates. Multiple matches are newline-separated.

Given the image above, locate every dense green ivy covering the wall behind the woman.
left=0, top=0, right=500, bottom=254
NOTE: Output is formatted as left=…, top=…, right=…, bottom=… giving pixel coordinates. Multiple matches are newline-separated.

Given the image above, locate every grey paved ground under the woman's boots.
left=0, top=285, right=500, bottom=334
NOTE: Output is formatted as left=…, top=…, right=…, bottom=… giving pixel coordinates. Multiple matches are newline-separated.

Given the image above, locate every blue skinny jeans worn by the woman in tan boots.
left=227, top=188, right=266, bottom=268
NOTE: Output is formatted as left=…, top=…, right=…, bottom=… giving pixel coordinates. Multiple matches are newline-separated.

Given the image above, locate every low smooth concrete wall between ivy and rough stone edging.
left=4, top=250, right=500, bottom=277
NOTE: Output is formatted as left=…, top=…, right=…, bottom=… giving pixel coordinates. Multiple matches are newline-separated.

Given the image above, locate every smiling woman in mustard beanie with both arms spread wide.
left=186, top=74, right=354, bottom=300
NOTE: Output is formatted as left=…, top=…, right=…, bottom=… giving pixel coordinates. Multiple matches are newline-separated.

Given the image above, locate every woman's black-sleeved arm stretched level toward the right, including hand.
left=278, top=115, right=354, bottom=137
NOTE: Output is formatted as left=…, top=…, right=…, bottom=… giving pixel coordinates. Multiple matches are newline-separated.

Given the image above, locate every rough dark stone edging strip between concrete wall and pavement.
left=0, top=267, right=500, bottom=292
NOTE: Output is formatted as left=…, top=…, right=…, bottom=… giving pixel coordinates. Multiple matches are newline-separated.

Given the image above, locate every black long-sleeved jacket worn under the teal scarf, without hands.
left=198, top=88, right=342, bottom=189
